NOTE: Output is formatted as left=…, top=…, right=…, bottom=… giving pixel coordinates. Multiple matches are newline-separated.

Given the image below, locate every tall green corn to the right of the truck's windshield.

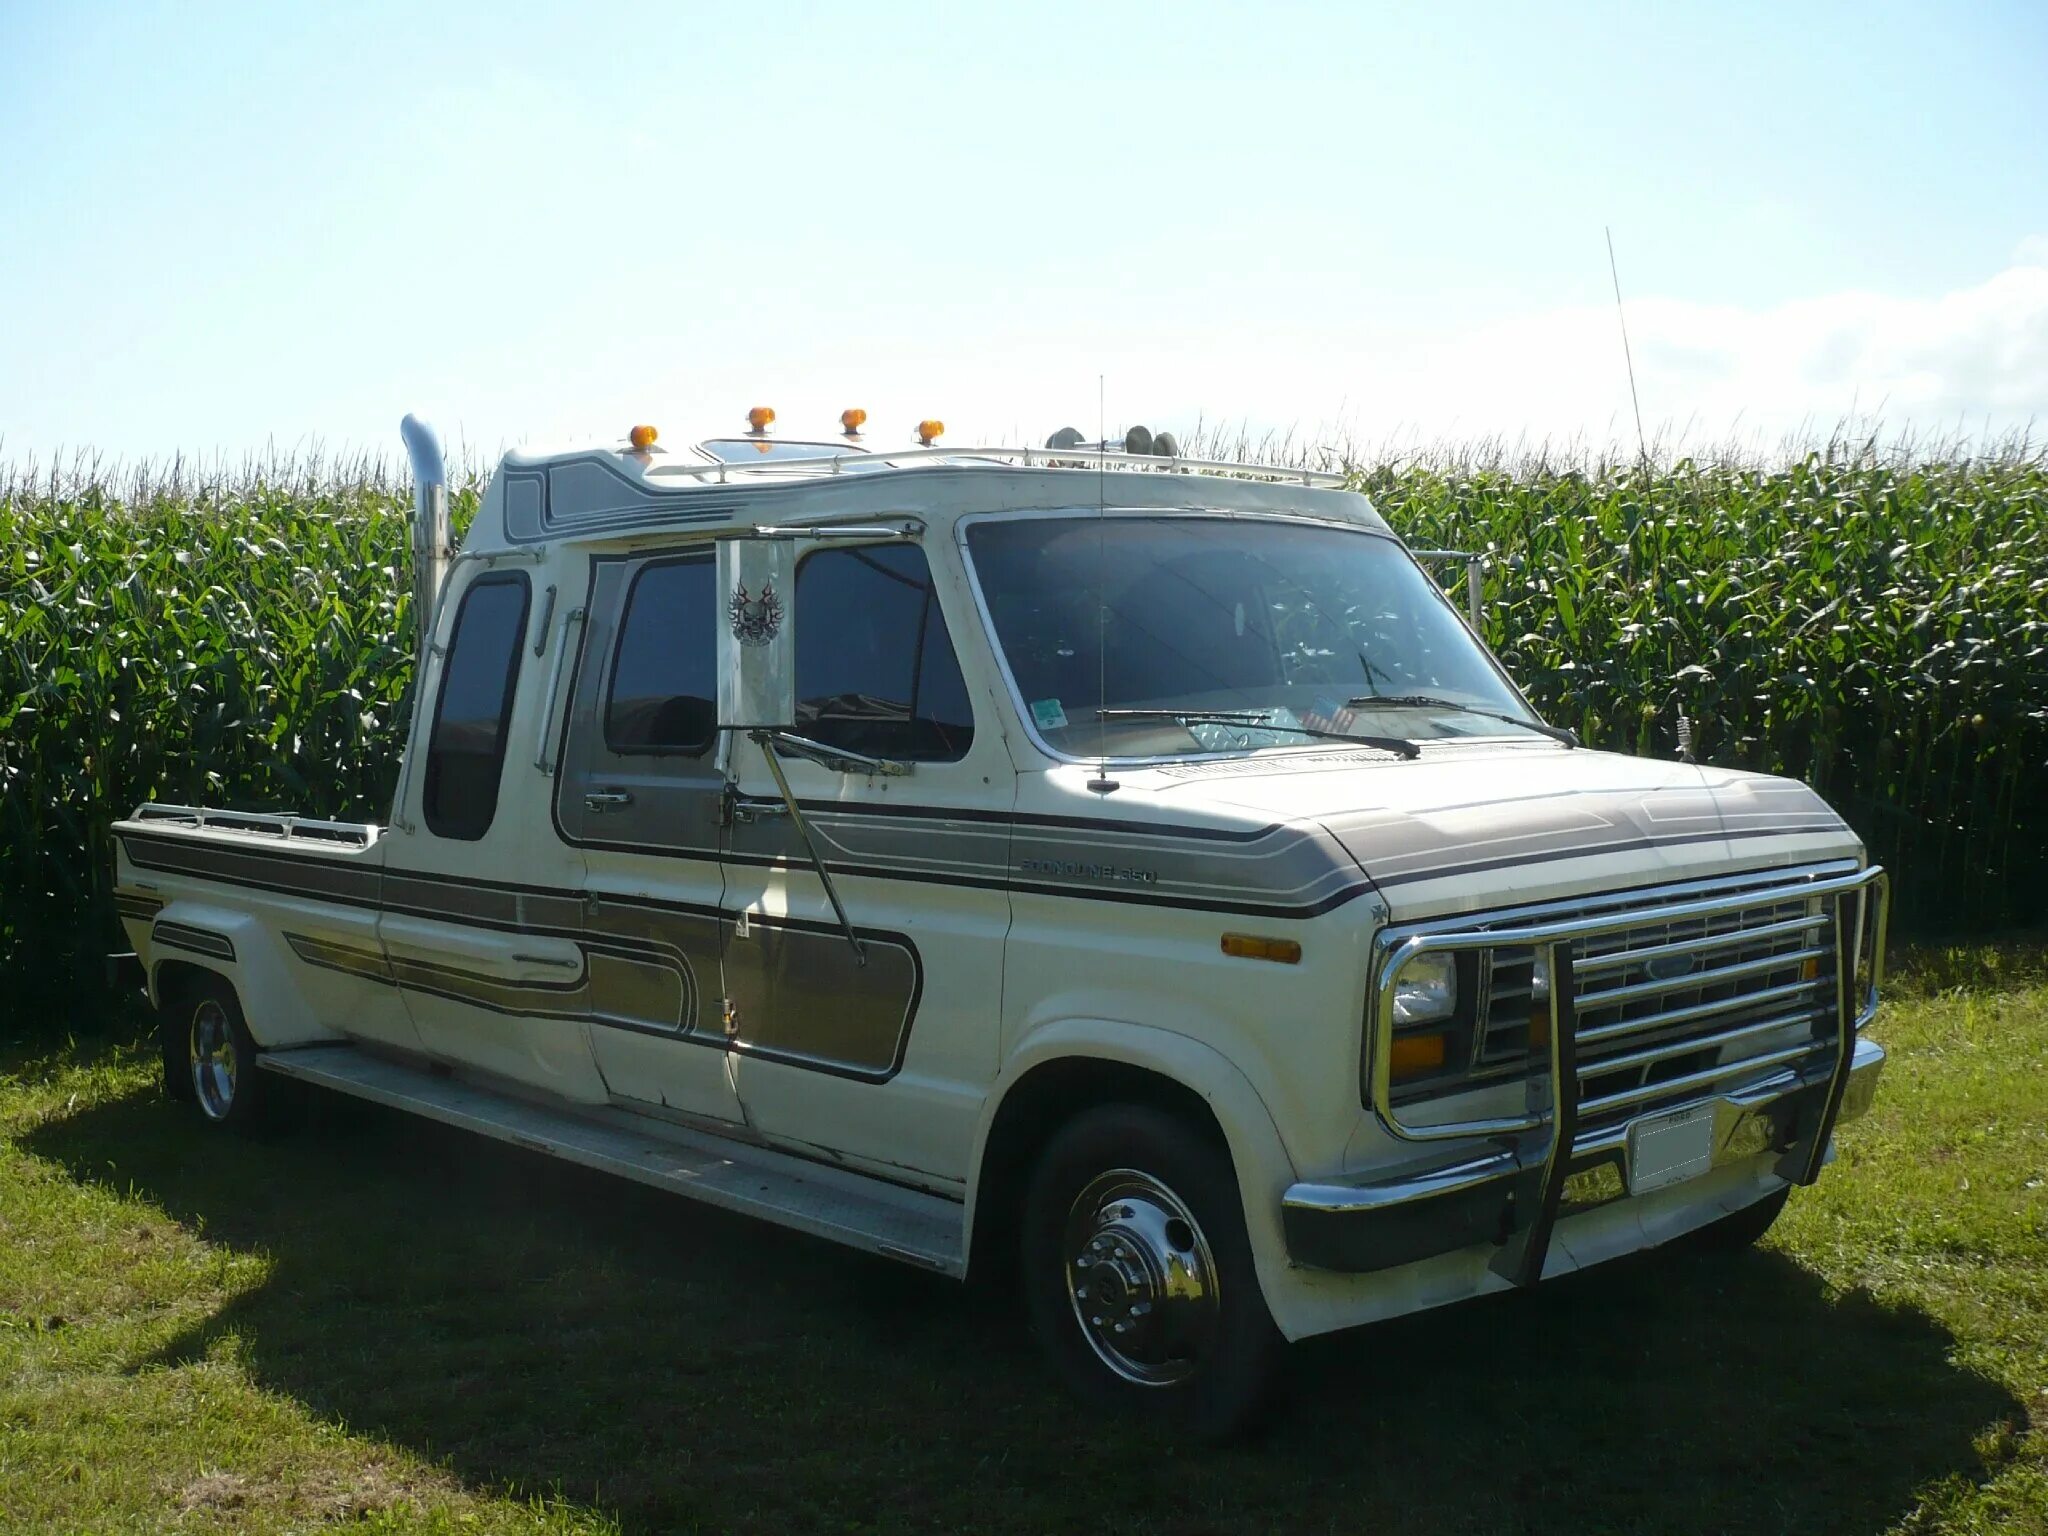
left=1362, top=453, right=2048, bottom=932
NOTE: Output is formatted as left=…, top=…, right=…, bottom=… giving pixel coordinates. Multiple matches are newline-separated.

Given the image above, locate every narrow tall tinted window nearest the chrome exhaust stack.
left=426, top=575, right=526, bottom=842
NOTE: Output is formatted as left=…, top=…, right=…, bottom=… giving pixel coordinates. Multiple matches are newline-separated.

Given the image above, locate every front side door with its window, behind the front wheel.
left=723, top=543, right=1016, bottom=1186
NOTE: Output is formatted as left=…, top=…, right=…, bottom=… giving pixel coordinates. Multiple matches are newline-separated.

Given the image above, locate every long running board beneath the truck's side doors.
left=256, top=1044, right=967, bottom=1276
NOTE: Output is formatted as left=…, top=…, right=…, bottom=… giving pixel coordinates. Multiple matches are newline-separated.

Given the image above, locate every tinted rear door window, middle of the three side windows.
left=604, top=549, right=719, bottom=756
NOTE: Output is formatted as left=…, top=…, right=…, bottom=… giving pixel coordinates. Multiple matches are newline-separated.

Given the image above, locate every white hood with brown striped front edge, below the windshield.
left=1097, top=741, right=1862, bottom=920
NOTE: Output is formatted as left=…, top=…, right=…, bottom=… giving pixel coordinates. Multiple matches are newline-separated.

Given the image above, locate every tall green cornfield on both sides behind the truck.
left=0, top=446, right=2048, bottom=1032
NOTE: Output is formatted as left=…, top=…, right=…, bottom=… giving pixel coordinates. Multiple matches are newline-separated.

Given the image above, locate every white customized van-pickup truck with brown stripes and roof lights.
left=117, top=412, right=1886, bottom=1436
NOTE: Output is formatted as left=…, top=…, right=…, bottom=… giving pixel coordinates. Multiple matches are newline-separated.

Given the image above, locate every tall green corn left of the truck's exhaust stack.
left=0, top=456, right=473, bottom=1036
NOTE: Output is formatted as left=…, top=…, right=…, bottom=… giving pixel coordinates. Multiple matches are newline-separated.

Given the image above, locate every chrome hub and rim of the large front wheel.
left=1065, top=1167, right=1217, bottom=1386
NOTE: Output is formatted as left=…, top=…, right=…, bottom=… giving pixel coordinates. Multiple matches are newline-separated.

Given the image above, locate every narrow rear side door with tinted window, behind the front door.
left=553, top=545, right=739, bottom=1120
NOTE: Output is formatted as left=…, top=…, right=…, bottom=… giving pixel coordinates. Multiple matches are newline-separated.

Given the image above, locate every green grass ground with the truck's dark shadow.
left=0, top=948, right=2048, bottom=1536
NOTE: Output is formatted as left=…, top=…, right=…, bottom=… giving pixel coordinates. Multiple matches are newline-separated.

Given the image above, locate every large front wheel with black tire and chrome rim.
left=1022, top=1104, right=1284, bottom=1442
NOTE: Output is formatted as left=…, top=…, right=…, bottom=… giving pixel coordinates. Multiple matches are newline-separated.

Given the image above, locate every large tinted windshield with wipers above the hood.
left=967, top=514, right=1532, bottom=758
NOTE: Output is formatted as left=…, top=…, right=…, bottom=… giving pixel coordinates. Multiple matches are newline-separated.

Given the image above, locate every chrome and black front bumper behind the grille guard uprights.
left=1280, top=1038, right=1884, bottom=1274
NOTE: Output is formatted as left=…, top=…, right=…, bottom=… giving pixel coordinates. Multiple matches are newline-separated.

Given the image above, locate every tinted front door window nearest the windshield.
left=797, top=545, right=975, bottom=762
